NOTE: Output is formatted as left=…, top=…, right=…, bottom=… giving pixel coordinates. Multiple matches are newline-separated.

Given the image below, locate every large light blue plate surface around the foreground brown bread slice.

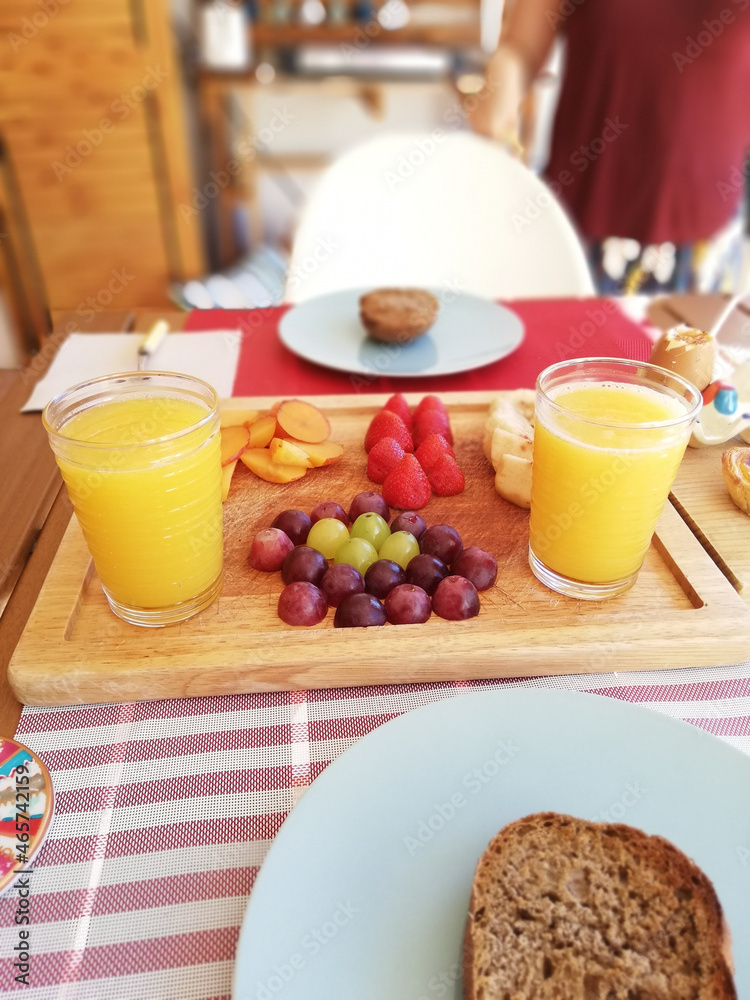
left=234, top=690, right=750, bottom=1000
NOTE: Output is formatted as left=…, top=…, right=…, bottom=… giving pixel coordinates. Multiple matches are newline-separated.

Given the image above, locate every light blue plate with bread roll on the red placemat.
left=279, top=288, right=524, bottom=378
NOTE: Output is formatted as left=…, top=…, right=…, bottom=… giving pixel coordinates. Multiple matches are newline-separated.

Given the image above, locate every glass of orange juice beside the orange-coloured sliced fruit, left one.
left=43, top=371, right=222, bottom=626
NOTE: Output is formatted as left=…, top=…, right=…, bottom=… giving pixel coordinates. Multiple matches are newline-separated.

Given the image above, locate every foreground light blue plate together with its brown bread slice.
left=233, top=689, right=750, bottom=1000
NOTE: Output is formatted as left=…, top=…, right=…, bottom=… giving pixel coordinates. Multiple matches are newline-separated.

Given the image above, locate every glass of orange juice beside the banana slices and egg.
left=529, top=358, right=702, bottom=600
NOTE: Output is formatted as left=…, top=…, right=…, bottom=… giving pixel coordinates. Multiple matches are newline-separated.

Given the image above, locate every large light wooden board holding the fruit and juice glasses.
left=9, top=393, right=750, bottom=705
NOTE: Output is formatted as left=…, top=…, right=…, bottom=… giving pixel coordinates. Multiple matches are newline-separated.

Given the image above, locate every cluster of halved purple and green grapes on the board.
left=250, top=491, right=497, bottom=628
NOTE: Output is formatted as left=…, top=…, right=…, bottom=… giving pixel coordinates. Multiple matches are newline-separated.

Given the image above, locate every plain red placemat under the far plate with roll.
left=185, top=299, right=652, bottom=396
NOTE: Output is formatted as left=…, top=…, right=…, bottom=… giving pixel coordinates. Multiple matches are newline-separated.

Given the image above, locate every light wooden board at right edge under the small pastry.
left=672, top=438, right=750, bottom=600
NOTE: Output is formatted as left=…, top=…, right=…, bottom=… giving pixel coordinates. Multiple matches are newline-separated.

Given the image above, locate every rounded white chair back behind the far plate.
left=285, top=130, right=594, bottom=302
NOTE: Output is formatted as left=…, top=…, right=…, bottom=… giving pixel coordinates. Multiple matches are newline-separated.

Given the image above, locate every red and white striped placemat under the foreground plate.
left=0, top=303, right=750, bottom=1000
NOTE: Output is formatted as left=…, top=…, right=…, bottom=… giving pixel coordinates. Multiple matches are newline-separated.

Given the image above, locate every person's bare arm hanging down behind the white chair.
left=469, top=0, right=562, bottom=141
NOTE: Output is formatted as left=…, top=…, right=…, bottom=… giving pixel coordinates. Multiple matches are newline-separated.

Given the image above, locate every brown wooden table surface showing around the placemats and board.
left=0, top=295, right=750, bottom=736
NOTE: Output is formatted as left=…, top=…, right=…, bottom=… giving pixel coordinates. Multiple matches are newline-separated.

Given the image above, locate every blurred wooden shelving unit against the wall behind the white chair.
left=194, top=0, right=484, bottom=278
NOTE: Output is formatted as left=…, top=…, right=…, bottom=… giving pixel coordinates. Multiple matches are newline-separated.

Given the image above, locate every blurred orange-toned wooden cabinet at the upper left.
left=0, top=0, right=204, bottom=315
